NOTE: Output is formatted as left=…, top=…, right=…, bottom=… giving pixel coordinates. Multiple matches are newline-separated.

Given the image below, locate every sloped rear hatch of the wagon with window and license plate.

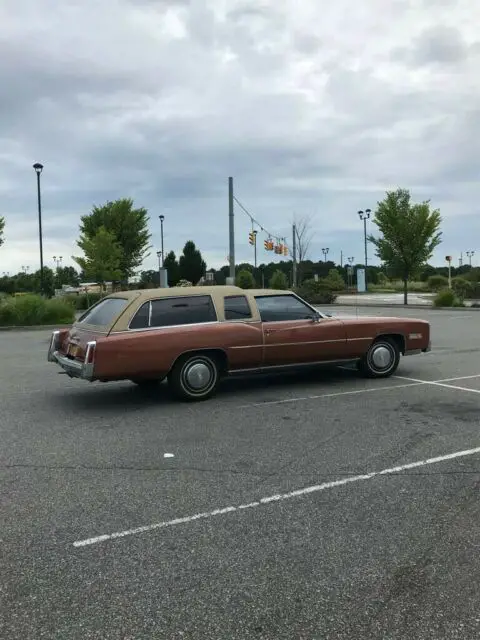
left=60, top=295, right=135, bottom=360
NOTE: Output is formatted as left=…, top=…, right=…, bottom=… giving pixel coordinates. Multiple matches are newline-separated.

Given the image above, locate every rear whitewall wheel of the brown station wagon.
left=168, top=353, right=220, bottom=402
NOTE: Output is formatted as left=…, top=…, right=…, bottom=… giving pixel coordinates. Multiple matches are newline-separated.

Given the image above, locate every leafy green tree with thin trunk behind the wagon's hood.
left=368, top=189, right=442, bottom=304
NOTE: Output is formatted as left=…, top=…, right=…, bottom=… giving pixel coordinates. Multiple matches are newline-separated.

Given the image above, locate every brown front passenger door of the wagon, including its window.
left=255, top=294, right=347, bottom=367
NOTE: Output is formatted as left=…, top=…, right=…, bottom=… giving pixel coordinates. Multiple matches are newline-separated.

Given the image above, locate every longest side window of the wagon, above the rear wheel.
left=150, top=296, right=217, bottom=327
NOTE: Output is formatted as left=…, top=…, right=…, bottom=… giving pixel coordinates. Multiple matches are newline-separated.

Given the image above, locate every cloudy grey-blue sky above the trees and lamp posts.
left=0, top=0, right=480, bottom=275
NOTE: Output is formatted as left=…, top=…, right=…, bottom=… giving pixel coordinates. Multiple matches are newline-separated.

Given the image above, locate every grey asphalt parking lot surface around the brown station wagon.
left=0, top=307, right=480, bottom=640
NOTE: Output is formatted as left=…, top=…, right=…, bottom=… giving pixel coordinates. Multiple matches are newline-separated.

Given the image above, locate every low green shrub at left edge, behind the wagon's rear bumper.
left=0, top=294, right=75, bottom=327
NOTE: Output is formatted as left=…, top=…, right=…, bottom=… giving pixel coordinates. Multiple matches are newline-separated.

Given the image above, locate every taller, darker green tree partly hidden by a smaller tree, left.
left=77, top=198, right=151, bottom=280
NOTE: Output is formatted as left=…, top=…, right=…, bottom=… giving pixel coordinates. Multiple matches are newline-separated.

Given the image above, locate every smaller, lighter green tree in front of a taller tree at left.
left=72, top=222, right=124, bottom=286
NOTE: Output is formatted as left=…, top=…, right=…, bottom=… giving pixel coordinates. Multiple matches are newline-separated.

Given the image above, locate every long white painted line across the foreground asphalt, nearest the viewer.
left=73, top=447, right=480, bottom=547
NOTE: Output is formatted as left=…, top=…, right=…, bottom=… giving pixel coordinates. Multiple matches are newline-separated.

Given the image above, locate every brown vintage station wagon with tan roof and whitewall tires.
left=48, top=286, right=430, bottom=400
